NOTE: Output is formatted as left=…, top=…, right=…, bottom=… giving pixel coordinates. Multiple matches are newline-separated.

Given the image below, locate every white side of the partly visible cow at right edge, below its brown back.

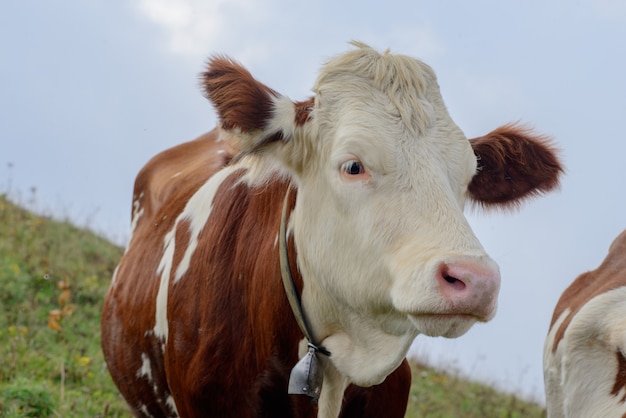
left=544, top=287, right=626, bottom=418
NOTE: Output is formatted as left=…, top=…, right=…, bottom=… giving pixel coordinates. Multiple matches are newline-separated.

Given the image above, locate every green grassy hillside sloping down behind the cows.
left=0, top=195, right=544, bottom=418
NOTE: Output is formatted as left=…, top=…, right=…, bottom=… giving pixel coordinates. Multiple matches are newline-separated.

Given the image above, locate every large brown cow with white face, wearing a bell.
left=102, top=43, right=562, bottom=418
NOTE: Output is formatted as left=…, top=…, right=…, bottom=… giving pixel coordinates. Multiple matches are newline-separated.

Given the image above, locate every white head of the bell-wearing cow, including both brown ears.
left=203, top=44, right=562, bottom=385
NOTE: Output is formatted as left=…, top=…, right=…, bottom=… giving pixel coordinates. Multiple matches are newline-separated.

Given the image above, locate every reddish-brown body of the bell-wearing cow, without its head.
left=102, top=131, right=411, bottom=417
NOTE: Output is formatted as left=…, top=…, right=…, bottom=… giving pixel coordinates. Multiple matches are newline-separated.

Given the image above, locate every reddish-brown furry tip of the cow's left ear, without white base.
left=201, top=56, right=279, bottom=132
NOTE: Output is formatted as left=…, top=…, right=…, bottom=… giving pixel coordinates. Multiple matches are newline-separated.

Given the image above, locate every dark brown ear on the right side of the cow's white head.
left=468, top=124, right=563, bottom=208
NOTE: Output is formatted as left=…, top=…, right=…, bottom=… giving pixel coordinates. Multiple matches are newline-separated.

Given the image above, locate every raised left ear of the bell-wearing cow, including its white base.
left=201, top=56, right=313, bottom=165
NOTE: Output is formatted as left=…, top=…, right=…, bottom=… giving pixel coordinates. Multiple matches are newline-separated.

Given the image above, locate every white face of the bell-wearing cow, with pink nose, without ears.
left=286, top=47, right=499, bottom=384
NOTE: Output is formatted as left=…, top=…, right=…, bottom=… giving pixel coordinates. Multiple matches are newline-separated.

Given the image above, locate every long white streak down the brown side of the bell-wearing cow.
left=154, top=165, right=240, bottom=343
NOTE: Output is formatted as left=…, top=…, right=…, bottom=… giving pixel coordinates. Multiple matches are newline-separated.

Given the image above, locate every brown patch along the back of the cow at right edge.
left=550, top=231, right=626, bottom=352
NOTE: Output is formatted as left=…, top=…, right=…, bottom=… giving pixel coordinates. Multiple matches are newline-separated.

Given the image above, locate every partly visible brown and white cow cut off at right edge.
left=543, top=231, right=626, bottom=418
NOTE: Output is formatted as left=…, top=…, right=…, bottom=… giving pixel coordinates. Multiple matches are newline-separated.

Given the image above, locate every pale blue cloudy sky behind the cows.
left=0, top=0, right=626, bottom=401
